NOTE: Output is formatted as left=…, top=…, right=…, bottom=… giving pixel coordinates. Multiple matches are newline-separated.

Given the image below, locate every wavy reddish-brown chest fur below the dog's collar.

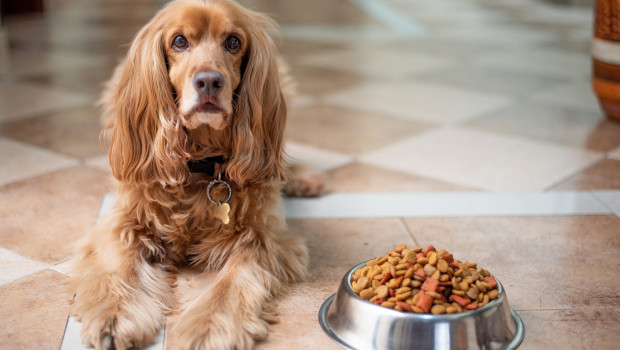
left=124, top=179, right=281, bottom=269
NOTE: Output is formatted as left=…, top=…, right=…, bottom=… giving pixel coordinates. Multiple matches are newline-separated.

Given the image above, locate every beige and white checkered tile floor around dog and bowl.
left=0, top=0, right=620, bottom=349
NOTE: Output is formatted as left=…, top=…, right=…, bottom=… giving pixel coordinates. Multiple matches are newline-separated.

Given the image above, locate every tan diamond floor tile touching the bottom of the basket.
left=467, top=103, right=620, bottom=152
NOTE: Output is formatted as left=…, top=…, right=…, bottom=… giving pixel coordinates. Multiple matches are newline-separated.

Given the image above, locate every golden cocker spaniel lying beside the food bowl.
left=71, top=0, right=321, bottom=350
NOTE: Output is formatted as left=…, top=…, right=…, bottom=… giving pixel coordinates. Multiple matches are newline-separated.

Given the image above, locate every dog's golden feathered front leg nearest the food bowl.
left=173, top=231, right=307, bottom=350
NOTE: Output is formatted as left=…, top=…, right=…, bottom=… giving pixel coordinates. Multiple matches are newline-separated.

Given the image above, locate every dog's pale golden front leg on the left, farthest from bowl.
left=71, top=215, right=173, bottom=350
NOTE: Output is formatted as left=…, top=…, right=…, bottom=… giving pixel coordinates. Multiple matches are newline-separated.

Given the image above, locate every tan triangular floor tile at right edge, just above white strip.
left=551, top=159, right=620, bottom=191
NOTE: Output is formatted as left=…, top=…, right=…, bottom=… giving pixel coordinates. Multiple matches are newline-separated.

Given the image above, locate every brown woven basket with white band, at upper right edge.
left=592, top=0, right=620, bottom=122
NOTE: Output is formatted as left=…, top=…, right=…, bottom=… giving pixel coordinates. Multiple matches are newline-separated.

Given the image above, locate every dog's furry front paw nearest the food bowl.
left=172, top=310, right=267, bottom=350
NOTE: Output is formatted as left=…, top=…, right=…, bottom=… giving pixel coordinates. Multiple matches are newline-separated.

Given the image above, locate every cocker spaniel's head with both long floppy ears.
left=104, top=0, right=286, bottom=189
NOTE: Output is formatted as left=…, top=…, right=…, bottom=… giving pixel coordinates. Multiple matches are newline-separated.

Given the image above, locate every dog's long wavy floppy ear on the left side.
left=103, top=9, right=188, bottom=186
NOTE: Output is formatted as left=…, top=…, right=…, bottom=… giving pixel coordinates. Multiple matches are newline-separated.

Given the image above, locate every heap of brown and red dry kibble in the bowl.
left=351, top=244, right=499, bottom=315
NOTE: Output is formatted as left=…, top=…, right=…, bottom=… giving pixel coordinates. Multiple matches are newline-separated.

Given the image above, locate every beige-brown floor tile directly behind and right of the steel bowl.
left=405, top=216, right=620, bottom=312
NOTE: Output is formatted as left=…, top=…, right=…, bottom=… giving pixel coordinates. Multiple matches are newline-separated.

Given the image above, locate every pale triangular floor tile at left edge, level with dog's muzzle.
left=0, top=82, right=95, bottom=123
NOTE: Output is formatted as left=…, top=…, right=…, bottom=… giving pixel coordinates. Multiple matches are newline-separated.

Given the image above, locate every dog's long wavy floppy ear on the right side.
left=226, top=12, right=287, bottom=185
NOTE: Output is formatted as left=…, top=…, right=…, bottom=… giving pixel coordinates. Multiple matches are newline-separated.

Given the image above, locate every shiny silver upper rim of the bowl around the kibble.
left=344, top=259, right=505, bottom=320
